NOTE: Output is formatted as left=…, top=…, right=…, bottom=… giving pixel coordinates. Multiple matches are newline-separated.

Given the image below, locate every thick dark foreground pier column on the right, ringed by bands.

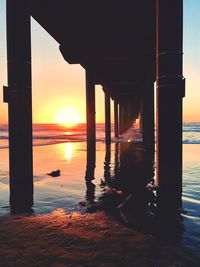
left=156, top=0, right=184, bottom=209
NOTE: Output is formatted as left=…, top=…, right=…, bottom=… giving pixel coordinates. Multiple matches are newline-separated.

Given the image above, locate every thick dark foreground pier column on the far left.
left=4, top=0, right=33, bottom=212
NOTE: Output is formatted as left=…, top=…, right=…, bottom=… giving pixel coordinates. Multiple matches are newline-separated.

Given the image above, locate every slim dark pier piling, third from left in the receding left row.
left=104, top=90, right=111, bottom=143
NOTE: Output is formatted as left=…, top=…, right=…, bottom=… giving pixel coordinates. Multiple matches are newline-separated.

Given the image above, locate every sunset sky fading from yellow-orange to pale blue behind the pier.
left=0, top=0, right=200, bottom=124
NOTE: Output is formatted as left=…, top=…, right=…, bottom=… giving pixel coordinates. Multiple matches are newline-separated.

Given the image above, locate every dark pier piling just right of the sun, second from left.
left=86, top=69, right=96, bottom=176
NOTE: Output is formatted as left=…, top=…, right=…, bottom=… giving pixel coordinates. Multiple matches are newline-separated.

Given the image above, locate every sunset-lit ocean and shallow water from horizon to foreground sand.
left=0, top=122, right=200, bottom=251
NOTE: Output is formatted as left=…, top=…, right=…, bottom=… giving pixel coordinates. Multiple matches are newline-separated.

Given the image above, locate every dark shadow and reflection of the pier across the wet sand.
left=85, top=143, right=184, bottom=245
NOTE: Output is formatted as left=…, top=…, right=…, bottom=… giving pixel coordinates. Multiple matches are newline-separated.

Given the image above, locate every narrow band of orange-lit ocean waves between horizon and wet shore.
left=0, top=122, right=200, bottom=149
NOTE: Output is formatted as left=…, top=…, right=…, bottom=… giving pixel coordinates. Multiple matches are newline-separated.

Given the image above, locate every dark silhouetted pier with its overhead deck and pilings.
left=4, top=0, right=184, bottom=214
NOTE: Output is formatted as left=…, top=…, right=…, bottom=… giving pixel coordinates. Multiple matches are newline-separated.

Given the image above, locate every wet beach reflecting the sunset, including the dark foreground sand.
left=0, top=137, right=199, bottom=267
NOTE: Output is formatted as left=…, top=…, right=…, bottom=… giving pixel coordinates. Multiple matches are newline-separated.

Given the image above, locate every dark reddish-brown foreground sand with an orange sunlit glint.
left=0, top=209, right=197, bottom=267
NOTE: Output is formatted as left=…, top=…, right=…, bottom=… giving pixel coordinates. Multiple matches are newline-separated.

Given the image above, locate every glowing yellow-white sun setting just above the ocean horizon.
left=54, top=107, right=82, bottom=125
